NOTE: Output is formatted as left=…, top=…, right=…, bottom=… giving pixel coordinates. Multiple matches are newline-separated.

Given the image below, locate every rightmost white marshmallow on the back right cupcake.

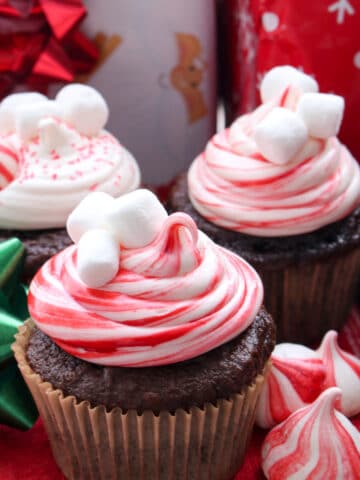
left=297, top=93, right=345, bottom=138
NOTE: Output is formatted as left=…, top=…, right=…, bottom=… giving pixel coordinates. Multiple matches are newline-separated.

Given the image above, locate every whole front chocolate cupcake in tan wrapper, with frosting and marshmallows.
left=13, top=190, right=275, bottom=480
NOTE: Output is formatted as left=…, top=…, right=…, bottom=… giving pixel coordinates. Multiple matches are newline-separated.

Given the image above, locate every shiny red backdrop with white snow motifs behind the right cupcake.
left=219, top=0, right=360, bottom=160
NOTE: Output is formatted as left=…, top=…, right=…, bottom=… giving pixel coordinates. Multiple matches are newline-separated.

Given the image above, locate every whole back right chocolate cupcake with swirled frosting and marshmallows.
left=170, top=67, right=360, bottom=344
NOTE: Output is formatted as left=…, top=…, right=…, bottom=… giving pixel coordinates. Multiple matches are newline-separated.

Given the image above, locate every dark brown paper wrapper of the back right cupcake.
left=258, top=248, right=360, bottom=345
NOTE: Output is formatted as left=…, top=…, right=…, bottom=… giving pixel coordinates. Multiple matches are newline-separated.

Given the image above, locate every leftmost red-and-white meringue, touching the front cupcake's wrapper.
left=255, top=343, right=326, bottom=428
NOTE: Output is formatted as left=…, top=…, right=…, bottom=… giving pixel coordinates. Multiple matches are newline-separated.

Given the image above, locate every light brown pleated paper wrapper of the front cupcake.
left=13, top=320, right=268, bottom=480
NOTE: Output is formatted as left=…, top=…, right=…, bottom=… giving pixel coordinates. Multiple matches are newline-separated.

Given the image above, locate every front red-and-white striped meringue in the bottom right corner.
left=262, top=387, right=360, bottom=480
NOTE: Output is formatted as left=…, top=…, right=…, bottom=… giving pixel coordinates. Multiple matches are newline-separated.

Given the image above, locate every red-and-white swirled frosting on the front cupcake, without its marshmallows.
left=29, top=213, right=263, bottom=367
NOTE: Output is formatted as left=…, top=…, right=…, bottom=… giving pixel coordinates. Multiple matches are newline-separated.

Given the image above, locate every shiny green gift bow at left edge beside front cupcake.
left=0, top=238, right=38, bottom=429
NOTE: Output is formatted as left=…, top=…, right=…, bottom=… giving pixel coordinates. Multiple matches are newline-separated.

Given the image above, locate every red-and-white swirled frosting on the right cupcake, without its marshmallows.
left=188, top=88, right=360, bottom=237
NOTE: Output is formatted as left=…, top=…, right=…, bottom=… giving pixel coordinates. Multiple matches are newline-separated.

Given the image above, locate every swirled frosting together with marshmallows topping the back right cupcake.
left=188, top=67, right=360, bottom=237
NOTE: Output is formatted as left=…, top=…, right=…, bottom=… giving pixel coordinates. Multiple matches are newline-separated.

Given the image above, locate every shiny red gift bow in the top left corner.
left=0, top=0, right=99, bottom=97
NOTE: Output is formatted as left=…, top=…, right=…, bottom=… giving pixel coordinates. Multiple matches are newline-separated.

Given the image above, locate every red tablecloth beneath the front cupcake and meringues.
left=0, top=309, right=360, bottom=480
